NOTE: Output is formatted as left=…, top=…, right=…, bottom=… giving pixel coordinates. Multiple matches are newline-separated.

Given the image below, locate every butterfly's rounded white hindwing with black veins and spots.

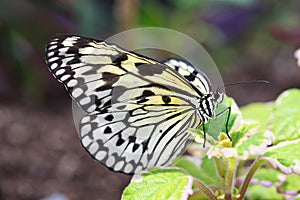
left=80, top=100, right=199, bottom=173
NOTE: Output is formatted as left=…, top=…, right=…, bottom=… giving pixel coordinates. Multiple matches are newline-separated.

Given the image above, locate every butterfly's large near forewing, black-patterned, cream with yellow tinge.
left=46, top=36, right=197, bottom=112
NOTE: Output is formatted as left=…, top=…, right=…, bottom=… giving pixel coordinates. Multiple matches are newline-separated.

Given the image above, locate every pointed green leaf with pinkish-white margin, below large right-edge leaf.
left=261, top=139, right=300, bottom=175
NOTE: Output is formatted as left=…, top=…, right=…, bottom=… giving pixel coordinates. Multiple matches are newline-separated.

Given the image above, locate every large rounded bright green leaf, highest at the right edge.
left=269, top=89, right=300, bottom=144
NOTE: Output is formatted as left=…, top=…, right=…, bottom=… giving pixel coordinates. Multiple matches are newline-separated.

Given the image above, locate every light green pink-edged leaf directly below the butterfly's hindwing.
left=122, top=168, right=193, bottom=200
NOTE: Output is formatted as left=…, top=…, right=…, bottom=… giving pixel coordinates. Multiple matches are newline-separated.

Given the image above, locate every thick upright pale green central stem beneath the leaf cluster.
left=224, top=158, right=237, bottom=200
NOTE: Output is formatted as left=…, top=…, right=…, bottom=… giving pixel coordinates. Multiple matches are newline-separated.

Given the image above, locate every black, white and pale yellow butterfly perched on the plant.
left=46, top=35, right=229, bottom=174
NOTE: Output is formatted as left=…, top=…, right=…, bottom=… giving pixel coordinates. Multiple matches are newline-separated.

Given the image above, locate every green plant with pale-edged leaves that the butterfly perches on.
left=122, top=89, right=300, bottom=200
